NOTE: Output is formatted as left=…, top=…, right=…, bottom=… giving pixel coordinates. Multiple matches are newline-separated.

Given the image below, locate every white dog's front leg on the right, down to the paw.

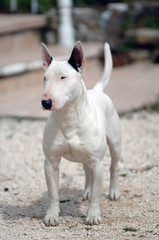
left=85, top=161, right=103, bottom=225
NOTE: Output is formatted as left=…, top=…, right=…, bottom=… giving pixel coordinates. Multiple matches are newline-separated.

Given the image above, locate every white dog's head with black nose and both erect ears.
left=41, top=42, right=85, bottom=110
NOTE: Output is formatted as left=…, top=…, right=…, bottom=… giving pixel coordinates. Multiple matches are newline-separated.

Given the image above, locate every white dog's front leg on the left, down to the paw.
left=44, top=159, right=60, bottom=226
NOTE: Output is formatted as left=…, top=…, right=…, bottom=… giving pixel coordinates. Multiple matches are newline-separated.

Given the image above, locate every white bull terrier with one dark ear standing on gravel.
left=41, top=41, right=121, bottom=226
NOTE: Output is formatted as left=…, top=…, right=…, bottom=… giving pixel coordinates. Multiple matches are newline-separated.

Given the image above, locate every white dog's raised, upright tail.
left=93, top=42, right=113, bottom=91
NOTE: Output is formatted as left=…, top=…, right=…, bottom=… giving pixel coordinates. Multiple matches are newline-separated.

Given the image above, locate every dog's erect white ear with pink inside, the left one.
left=41, top=43, right=53, bottom=71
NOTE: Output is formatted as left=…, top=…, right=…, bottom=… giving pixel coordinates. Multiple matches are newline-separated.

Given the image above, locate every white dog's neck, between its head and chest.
left=53, top=80, right=88, bottom=138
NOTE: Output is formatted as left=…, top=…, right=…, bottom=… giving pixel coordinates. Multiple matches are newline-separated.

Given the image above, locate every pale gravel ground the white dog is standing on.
left=0, top=112, right=159, bottom=240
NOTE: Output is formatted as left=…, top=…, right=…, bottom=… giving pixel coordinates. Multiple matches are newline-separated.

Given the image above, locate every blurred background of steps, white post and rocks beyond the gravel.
left=0, top=0, right=159, bottom=117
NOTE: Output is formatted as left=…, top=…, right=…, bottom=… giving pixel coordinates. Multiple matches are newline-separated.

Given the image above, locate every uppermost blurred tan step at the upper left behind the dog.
left=0, top=14, right=46, bottom=63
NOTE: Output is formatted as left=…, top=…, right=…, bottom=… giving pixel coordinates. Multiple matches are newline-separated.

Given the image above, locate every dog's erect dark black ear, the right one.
left=68, top=41, right=86, bottom=73
